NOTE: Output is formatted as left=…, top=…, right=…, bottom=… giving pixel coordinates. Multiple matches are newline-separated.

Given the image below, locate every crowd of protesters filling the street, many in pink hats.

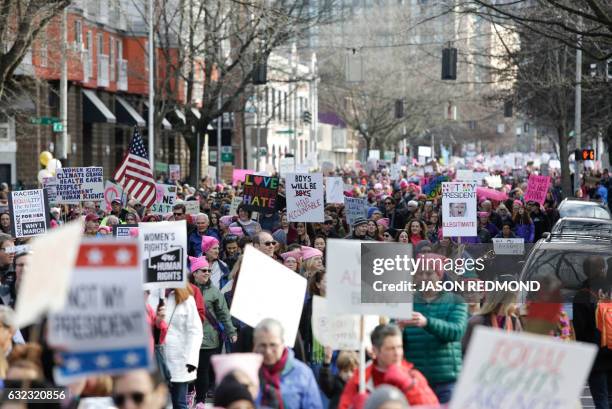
left=0, top=159, right=612, bottom=409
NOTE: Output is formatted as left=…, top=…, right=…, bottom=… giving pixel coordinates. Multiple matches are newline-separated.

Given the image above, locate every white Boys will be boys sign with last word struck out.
left=285, top=173, right=324, bottom=223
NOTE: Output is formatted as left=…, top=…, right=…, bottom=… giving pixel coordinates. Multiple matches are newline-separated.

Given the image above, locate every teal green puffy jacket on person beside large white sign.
left=403, top=293, right=468, bottom=385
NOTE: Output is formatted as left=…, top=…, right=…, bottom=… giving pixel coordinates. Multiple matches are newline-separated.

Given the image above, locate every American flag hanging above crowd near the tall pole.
left=115, top=129, right=156, bottom=207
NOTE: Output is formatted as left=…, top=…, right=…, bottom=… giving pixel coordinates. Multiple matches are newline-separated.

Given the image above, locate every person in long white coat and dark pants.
left=165, top=286, right=203, bottom=409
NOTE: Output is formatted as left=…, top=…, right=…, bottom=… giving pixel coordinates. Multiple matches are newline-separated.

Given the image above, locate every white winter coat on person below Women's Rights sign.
left=164, top=292, right=203, bottom=383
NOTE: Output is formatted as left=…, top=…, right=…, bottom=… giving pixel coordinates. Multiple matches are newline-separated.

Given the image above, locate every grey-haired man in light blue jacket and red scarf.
left=253, top=319, right=323, bottom=409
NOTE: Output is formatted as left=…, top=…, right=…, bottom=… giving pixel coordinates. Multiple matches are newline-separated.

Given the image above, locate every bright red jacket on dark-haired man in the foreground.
left=338, top=360, right=439, bottom=409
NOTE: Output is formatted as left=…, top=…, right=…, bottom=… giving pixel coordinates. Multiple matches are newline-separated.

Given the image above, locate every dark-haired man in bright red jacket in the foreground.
left=338, top=325, right=438, bottom=409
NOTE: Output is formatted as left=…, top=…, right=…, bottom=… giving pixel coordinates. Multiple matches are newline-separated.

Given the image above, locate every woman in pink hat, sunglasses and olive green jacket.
left=190, top=257, right=238, bottom=404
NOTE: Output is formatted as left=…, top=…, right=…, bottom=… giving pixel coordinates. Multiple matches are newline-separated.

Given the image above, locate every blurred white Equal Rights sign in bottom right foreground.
left=449, top=325, right=597, bottom=409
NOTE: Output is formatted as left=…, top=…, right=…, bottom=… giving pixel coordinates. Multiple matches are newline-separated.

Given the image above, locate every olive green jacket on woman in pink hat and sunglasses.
left=196, top=281, right=236, bottom=349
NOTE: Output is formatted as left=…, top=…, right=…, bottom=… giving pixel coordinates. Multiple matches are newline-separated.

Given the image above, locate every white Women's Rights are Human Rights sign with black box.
left=138, top=220, right=187, bottom=289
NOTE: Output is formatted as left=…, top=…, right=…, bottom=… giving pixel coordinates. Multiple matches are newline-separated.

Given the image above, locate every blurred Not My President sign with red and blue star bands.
left=47, top=241, right=151, bottom=385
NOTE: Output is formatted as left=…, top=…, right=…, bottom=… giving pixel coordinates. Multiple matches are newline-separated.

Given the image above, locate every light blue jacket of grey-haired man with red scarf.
left=257, top=349, right=323, bottom=409
